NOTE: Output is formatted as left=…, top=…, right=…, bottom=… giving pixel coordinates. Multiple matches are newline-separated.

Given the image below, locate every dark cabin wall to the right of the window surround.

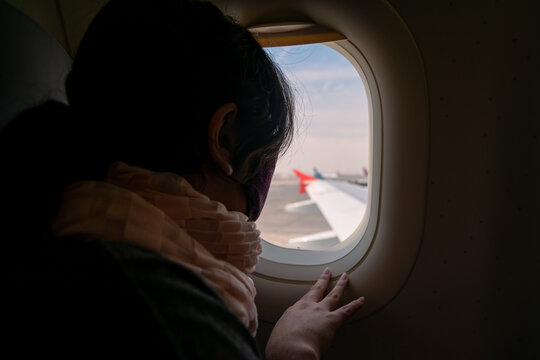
left=326, top=0, right=540, bottom=359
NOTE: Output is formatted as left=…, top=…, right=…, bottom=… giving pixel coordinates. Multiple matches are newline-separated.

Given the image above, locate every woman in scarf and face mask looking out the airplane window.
left=0, top=0, right=363, bottom=359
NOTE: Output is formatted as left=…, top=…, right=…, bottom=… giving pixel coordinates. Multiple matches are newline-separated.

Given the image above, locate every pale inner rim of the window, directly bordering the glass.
left=254, top=37, right=382, bottom=281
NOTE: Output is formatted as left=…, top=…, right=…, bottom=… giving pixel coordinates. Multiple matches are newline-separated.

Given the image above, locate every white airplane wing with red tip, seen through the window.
left=285, top=169, right=367, bottom=249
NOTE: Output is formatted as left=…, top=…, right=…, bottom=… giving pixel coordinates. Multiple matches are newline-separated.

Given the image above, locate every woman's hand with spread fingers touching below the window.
left=266, top=269, right=364, bottom=360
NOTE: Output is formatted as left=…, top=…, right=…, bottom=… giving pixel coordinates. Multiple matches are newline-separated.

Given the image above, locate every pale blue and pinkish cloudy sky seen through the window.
left=265, top=44, right=369, bottom=176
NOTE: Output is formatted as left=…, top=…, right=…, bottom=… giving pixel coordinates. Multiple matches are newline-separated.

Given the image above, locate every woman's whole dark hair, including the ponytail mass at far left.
left=0, top=0, right=293, bottom=256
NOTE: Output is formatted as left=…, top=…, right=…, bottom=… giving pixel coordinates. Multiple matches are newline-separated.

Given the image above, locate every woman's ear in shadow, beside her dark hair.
left=208, top=103, right=238, bottom=176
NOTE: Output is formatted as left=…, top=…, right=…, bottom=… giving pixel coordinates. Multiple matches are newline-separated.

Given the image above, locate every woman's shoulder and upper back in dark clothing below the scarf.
left=6, top=236, right=261, bottom=359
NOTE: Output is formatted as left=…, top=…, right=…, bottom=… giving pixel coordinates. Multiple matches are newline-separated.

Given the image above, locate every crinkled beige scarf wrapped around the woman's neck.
left=52, top=163, right=261, bottom=334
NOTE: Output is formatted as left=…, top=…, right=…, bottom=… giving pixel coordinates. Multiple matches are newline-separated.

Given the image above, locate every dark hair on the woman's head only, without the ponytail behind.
left=66, top=0, right=293, bottom=181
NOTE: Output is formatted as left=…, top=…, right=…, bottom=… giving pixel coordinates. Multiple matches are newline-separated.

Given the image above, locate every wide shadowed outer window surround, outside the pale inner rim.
left=213, top=0, right=429, bottom=324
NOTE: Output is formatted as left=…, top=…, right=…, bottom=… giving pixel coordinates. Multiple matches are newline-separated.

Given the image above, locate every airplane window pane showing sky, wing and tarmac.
left=258, top=44, right=370, bottom=250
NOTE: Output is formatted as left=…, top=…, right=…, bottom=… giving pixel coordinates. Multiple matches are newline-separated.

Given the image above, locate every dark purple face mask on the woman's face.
left=244, top=160, right=276, bottom=221
